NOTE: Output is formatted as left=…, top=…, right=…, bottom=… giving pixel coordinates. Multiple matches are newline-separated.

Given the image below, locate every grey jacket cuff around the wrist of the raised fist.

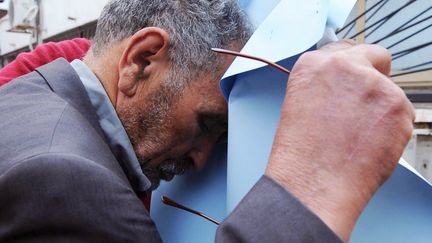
left=216, top=176, right=342, bottom=243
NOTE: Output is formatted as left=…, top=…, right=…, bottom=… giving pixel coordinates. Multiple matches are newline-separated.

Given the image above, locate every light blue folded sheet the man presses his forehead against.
left=151, top=0, right=432, bottom=243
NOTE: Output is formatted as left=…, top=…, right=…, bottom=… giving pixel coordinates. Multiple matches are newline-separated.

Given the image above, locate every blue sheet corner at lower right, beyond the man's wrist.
left=350, top=165, right=432, bottom=243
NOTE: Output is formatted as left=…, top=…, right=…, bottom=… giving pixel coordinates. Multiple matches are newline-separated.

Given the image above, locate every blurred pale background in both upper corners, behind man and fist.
left=0, top=0, right=432, bottom=181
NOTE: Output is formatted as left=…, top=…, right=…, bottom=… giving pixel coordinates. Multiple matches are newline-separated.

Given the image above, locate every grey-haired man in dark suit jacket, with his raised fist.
left=0, top=0, right=414, bottom=242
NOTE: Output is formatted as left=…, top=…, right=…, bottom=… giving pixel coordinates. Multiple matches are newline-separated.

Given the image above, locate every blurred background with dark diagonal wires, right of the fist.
left=337, top=0, right=432, bottom=181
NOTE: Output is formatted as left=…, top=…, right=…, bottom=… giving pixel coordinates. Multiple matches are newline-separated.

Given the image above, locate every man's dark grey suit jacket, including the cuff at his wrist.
left=0, top=59, right=339, bottom=242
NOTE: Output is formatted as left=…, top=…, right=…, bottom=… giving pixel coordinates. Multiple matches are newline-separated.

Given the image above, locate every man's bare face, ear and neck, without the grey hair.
left=85, top=27, right=239, bottom=190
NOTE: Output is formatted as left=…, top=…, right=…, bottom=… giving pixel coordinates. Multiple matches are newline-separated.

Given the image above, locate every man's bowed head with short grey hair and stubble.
left=86, top=0, right=250, bottom=188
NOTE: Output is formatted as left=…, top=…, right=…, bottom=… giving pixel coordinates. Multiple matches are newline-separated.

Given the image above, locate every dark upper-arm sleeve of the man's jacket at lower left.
left=0, top=154, right=161, bottom=242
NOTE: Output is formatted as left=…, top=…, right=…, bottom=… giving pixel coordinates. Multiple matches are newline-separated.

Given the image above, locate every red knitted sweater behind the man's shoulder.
left=0, top=38, right=91, bottom=86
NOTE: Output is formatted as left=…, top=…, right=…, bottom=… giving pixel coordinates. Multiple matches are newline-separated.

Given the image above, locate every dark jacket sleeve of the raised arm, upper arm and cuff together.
left=0, top=154, right=340, bottom=243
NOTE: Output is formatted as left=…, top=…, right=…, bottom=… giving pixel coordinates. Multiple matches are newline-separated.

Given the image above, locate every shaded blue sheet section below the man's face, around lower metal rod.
left=151, top=144, right=226, bottom=243
